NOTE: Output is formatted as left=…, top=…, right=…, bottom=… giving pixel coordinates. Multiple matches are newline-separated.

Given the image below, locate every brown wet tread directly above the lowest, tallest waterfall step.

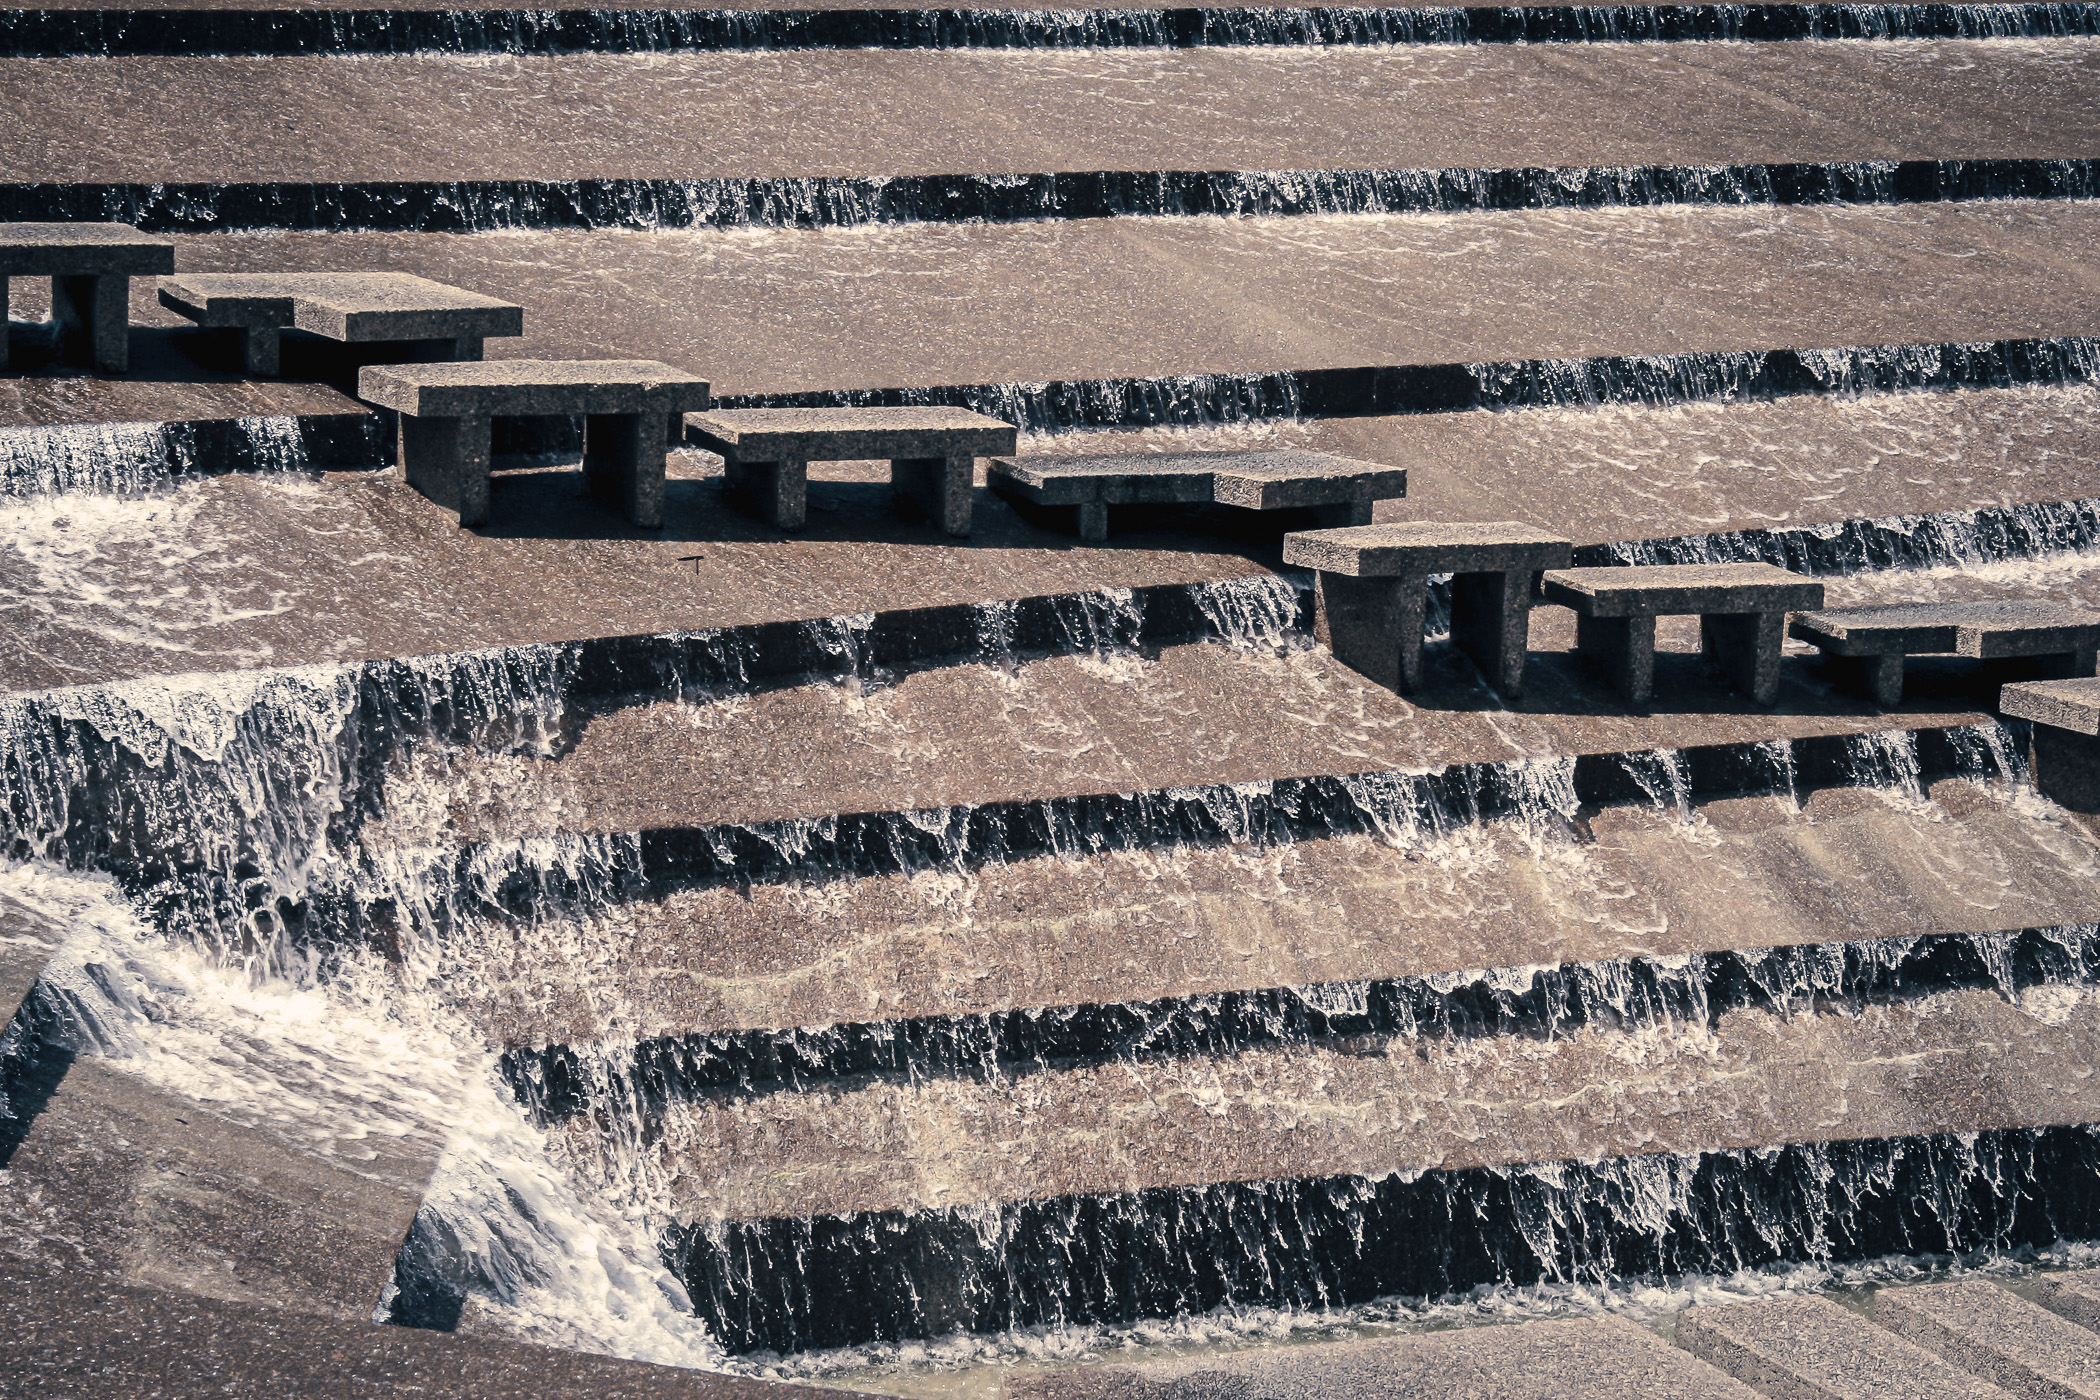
left=613, top=989, right=2100, bottom=1222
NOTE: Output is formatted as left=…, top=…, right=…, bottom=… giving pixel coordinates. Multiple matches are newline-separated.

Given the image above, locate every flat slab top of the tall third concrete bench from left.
left=357, top=359, right=708, bottom=418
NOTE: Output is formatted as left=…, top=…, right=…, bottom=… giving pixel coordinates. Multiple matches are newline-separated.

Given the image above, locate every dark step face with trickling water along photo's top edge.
left=0, top=4, right=2100, bottom=57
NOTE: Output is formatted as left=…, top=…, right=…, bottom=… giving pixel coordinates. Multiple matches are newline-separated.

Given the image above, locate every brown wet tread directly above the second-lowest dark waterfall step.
left=447, top=781, right=2100, bottom=1045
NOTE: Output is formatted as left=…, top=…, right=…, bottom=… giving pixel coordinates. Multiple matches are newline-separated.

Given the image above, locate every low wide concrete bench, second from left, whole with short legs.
left=160, top=273, right=525, bottom=376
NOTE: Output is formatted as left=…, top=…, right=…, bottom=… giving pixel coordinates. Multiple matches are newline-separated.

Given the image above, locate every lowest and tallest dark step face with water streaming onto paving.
left=646, top=1127, right=2100, bottom=1352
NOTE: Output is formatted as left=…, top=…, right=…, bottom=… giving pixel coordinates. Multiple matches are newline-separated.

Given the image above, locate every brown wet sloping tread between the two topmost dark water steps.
left=0, top=40, right=2100, bottom=183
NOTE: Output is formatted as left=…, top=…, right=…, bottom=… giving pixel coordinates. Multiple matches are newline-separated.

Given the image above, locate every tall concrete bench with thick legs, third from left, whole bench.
left=357, top=359, right=708, bottom=527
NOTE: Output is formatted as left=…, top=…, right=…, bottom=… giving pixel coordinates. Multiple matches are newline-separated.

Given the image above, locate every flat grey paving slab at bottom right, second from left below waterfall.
left=1678, top=1297, right=2006, bottom=1400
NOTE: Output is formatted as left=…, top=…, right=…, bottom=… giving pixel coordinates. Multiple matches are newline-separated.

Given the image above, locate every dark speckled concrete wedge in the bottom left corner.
left=0, top=1264, right=869, bottom=1400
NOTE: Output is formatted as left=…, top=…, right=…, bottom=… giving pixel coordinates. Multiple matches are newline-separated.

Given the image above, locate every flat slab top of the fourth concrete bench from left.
left=685, top=405, right=1019, bottom=462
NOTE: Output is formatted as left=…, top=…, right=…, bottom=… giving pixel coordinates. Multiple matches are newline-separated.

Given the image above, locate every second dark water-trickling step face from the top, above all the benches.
left=0, top=159, right=2100, bottom=233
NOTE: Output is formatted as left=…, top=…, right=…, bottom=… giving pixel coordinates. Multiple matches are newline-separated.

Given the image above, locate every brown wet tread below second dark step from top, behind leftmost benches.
left=106, top=199, right=2100, bottom=395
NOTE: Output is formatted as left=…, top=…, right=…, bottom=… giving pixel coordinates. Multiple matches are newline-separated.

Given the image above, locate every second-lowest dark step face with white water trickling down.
left=502, top=926, right=2100, bottom=1140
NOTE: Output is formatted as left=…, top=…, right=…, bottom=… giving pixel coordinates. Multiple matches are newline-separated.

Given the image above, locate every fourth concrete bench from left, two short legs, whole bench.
left=685, top=405, right=1019, bottom=535
